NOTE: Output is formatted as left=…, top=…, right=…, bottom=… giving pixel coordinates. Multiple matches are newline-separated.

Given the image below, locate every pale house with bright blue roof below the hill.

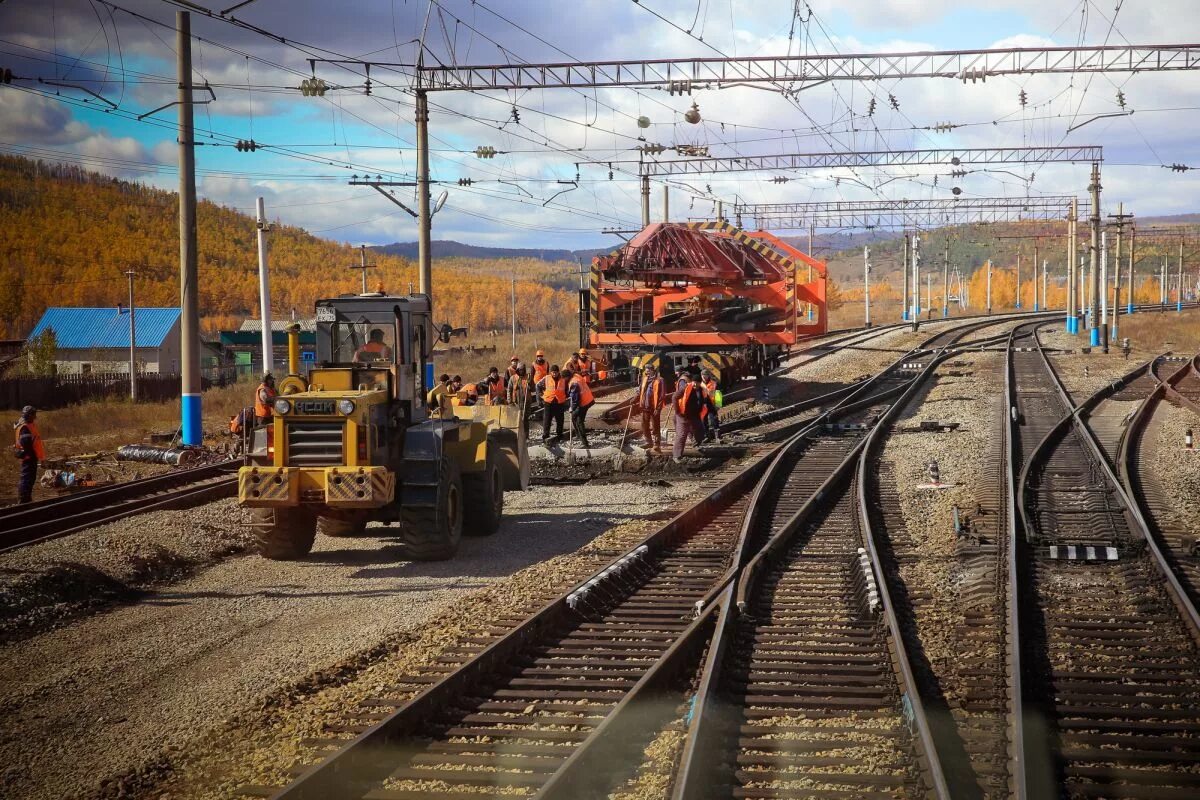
left=29, top=306, right=180, bottom=374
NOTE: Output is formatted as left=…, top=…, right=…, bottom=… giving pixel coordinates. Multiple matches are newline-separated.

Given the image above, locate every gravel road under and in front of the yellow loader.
left=0, top=480, right=696, bottom=799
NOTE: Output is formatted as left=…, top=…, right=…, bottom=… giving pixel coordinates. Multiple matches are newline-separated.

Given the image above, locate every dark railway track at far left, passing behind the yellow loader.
left=0, top=462, right=238, bottom=553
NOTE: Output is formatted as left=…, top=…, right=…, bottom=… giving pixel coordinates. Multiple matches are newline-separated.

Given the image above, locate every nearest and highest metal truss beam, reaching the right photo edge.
left=405, top=43, right=1200, bottom=91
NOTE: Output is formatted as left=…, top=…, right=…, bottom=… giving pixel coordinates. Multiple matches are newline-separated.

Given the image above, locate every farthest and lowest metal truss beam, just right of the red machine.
left=734, top=196, right=1082, bottom=230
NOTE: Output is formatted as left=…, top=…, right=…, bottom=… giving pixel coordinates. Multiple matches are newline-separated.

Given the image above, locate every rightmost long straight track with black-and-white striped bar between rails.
left=1008, top=321, right=1200, bottom=798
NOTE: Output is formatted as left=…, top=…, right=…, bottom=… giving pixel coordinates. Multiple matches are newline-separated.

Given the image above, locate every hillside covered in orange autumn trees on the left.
left=0, top=156, right=577, bottom=338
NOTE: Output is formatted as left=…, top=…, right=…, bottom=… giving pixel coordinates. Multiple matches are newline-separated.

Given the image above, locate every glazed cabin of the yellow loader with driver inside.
left=308, top=293, right=437, bottom=425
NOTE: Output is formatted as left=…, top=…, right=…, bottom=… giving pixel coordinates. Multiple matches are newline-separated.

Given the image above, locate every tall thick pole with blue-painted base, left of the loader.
left=175, top=11, right=204, bottom=446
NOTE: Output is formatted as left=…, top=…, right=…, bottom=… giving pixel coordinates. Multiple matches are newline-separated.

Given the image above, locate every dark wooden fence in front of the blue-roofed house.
left=0, top=369, right=236, bottom=409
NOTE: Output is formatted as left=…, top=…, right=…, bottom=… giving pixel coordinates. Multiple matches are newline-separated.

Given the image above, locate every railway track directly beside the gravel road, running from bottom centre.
left=258, top=320, right=1022, bottom=800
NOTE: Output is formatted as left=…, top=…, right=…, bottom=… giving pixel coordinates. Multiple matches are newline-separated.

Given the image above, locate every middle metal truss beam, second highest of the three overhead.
left=628, top=145, right=1104, bottom=178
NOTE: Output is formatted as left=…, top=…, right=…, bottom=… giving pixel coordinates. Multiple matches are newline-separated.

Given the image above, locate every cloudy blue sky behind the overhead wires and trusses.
left=0, top=0, right=1200, bottom=247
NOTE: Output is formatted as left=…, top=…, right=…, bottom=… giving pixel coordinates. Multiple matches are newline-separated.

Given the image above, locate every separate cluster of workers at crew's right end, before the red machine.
left=637, top=356, right=721, bottom=461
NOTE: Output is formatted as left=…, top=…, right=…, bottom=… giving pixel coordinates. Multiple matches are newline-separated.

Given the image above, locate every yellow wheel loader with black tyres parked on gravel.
left=238, top=293, right=529, bottom=560
